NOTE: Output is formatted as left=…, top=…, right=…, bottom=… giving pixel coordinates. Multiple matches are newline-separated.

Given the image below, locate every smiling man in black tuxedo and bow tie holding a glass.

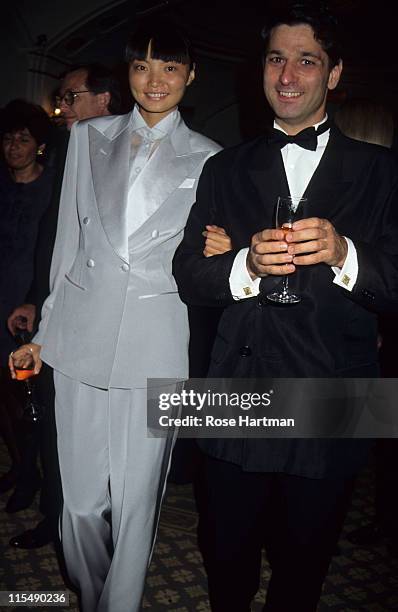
left=174, top=4, right=398, bottom=612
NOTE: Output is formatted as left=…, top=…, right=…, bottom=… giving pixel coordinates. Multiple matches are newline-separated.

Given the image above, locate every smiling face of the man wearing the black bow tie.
left=264, top=24, right=342, bottom=134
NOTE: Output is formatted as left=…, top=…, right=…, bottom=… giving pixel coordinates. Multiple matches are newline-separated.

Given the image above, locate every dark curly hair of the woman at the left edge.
left=0, top=99, right=51, bottom=145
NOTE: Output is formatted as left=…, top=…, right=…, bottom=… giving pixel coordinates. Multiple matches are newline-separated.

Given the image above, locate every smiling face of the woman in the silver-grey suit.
left=129, top=49, right=195, bottom=126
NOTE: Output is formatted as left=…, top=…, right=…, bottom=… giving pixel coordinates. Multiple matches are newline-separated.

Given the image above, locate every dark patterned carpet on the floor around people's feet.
left=0, top=446, right=398, bottom=612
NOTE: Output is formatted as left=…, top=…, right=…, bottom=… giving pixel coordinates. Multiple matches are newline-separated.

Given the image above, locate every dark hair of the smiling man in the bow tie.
left=261, top=2, right=341, bottom=70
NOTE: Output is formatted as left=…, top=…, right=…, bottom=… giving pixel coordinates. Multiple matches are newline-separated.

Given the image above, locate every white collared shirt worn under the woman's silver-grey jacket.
left=127, top=106, right=180, bottom=236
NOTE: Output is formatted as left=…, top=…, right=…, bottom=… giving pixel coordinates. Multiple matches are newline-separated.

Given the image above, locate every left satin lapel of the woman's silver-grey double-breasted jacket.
left=88, top=117, right=131, bottom=262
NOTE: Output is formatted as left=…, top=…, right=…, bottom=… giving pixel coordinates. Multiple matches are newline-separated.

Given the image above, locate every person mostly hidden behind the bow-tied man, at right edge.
left=334, top=98, right=398, bottom=557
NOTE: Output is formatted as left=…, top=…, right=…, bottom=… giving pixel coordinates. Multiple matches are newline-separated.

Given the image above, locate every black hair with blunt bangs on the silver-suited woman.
left=126, top=18, right=195, bottom=69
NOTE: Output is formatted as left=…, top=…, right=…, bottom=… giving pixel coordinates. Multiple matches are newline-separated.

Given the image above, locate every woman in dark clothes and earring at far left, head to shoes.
left=0, top=100, right=53, bottom=504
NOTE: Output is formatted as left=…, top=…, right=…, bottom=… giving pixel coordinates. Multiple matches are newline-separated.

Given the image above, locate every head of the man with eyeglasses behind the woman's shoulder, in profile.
left=56, top=64, right=120, bottom=130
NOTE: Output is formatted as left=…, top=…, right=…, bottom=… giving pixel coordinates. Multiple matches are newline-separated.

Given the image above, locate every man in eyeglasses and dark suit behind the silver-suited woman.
left=8, top=64, right=120, bottom=549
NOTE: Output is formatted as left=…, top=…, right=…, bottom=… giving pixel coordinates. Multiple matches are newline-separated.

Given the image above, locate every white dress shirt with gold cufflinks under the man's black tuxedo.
left=229, top=116, right=358, bottom=300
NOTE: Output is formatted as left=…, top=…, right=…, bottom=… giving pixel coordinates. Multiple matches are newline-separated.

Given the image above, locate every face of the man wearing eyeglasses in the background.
left=59, top=70, right=109, bottom=130
